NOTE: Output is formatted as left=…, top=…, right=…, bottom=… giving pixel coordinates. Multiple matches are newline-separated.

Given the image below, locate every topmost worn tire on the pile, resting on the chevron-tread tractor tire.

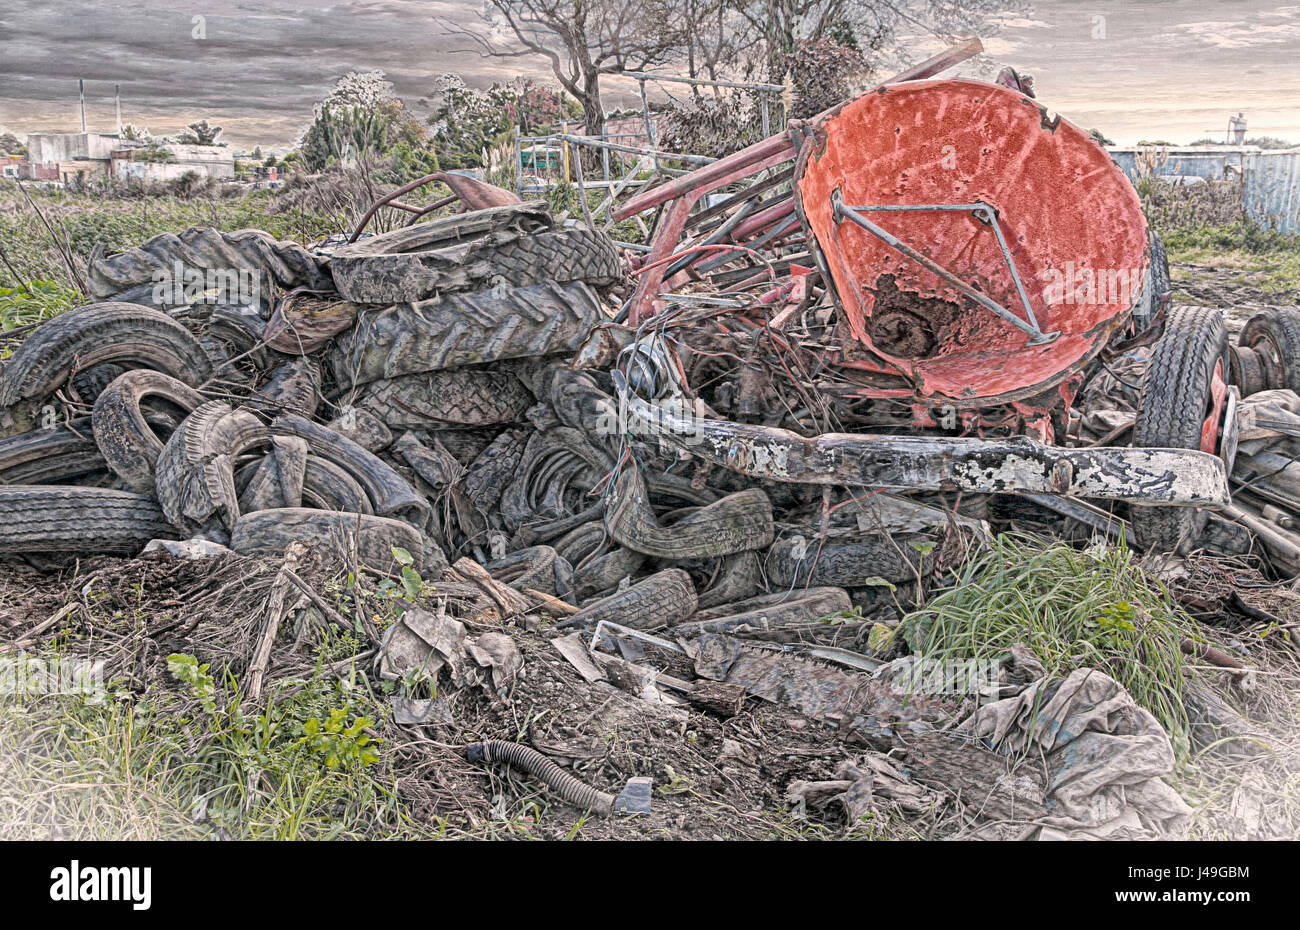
left=330, top=202, right=623, bottom=303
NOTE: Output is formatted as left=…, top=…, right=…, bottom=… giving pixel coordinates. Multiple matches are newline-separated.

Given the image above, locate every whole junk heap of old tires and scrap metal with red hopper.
left=0, top=41, right=1300, bottom=837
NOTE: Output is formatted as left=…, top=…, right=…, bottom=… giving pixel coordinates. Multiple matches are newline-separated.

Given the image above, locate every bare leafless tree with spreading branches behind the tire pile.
left=441, top=0, right=686, bottom=135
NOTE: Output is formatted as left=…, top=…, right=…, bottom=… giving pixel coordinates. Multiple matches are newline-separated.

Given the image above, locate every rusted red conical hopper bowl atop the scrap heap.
left=797, top=81, right=1148, bottom=406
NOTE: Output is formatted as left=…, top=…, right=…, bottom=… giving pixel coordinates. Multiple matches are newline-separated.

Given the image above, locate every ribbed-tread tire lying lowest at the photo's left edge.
left=0, top=485, right=177, bottom=555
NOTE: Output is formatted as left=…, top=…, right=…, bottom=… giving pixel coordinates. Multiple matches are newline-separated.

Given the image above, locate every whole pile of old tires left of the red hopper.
left=0, top=203, right=922, bottom=639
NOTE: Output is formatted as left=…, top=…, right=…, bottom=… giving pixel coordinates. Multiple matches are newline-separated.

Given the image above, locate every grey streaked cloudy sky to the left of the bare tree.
left=0, top=0, right=547, bottom=144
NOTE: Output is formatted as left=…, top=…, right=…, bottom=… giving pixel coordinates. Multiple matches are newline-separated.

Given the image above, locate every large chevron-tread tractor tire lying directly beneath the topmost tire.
left=329, top=282, right=606, bottom=388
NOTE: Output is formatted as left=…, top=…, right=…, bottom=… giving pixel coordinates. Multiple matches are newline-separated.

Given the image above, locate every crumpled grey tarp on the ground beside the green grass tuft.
left=956, top=669, right=1192, bottom=839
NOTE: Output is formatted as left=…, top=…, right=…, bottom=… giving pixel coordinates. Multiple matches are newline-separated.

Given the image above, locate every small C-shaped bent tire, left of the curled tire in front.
left=91, top=368, right=203, bottom=494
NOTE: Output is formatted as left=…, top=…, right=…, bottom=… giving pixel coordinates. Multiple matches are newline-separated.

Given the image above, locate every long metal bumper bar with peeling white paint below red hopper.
left=614, top=372, right=1229, bottom=509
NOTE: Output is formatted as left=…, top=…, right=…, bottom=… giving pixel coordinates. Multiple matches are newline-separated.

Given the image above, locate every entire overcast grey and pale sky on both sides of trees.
left=0, top=0, right=1300, bottom=147
